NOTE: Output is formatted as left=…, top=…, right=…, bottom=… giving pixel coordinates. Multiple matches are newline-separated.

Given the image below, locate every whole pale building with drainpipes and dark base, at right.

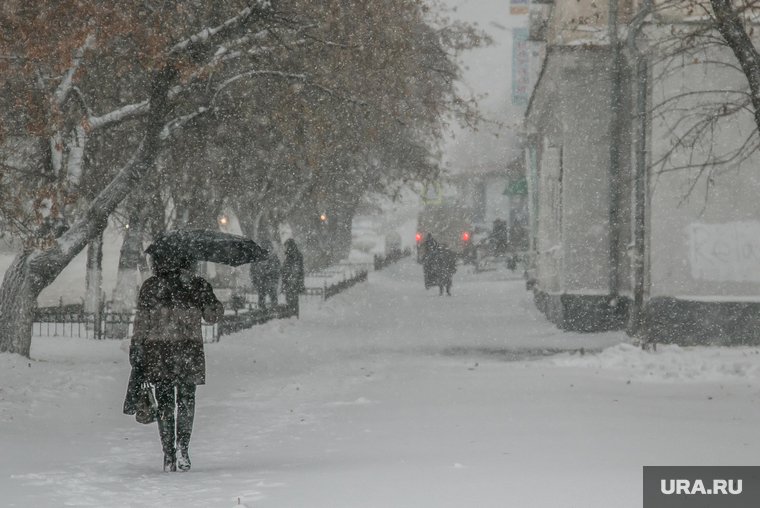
left=525, top=0, right=760, bottom=344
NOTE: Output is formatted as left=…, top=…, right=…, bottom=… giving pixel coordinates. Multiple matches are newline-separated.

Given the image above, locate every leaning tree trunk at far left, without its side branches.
left=0, top=62, right=178, bottom=357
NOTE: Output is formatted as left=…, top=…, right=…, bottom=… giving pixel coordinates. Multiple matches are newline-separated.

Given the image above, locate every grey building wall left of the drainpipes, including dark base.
left=528, top=48, right=630, bottom=331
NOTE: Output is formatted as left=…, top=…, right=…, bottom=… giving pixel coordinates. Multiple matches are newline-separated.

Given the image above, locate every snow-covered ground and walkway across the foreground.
left=0, top=259, right=760, bottom=508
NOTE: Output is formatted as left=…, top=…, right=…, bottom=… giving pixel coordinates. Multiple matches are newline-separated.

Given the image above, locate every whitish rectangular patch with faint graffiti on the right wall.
left=688, top=222, right=760, bottom=282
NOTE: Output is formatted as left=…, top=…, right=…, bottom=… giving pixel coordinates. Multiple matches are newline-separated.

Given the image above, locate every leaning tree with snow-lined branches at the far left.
left=0, top=2, right=280, bottom=356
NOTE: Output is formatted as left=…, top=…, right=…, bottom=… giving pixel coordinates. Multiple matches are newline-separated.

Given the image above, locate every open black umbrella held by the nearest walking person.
left=145, top=229, right=267, bottom=266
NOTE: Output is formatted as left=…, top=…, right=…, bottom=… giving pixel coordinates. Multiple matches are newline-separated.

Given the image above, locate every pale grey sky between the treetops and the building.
left=444, top=0, right=528, bottom=172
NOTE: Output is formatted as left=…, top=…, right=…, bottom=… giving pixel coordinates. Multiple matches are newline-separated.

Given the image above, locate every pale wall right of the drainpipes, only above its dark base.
left=649, top=34, right=760, bottom=300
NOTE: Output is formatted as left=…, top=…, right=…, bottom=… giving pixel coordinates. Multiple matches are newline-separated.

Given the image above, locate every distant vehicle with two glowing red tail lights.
left=415, top=205, right=475, bottom=263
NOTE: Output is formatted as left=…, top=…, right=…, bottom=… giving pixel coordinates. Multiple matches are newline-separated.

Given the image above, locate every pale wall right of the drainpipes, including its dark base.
left=647, top=29, right=760, bottom=345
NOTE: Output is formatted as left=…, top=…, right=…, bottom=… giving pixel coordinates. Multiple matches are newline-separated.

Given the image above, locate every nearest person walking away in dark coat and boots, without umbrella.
left=129, top=256, right=224, bottom=472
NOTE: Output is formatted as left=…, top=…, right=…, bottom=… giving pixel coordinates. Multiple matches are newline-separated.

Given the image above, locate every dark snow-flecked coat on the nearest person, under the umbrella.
left=129, top=272, right=224, bottom=385
